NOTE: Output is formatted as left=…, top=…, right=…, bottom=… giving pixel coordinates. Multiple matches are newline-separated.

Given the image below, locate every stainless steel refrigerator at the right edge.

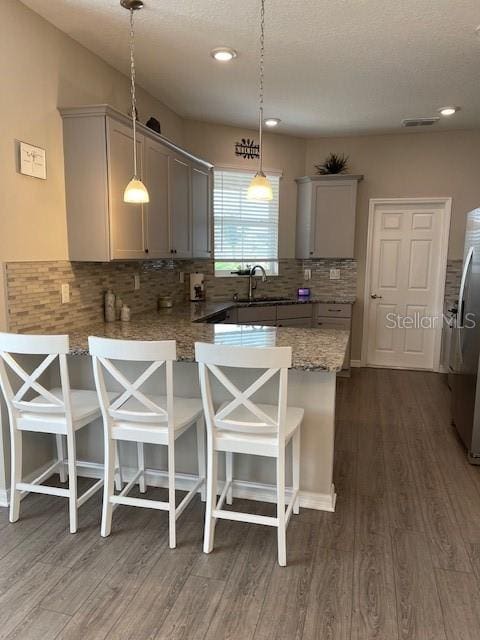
left=449, top=208, right=480, bottom=464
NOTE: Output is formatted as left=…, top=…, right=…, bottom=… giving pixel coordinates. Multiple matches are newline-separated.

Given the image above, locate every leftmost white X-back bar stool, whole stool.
left=0, top=333, right=103, bottom=533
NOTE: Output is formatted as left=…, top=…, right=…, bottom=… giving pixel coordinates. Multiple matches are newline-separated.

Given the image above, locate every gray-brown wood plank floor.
left=0, top=369, right=480, bottom=640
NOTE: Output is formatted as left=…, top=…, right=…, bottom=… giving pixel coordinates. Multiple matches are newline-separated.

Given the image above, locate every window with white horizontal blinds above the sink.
left=213, top=169, right=280, bottom=276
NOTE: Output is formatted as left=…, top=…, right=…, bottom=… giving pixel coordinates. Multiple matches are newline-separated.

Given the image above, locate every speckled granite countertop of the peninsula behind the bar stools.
left=70, top=302, right=350, bottom=372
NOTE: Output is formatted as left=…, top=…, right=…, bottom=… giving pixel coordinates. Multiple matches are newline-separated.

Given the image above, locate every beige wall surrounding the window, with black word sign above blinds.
left=183, top=120, right=306, bottom=258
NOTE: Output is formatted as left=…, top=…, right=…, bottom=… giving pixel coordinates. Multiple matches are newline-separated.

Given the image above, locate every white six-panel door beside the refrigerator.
left=365, top=201, right=446, bottom=369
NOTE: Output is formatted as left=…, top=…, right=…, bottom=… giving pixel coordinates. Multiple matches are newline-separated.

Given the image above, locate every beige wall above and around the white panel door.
left=306, top=131, right=480, bottom=359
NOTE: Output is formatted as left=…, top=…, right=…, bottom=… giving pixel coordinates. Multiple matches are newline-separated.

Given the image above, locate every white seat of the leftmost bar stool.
left=17, top=388, right=113, bottom=435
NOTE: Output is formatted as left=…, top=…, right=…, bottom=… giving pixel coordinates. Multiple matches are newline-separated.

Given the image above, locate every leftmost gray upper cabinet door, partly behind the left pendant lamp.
left=107, top=119, right=147, bottom=260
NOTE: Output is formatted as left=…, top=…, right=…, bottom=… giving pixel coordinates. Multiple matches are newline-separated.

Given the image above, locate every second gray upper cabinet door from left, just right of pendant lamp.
left=144, top=139, right=170, bottom=258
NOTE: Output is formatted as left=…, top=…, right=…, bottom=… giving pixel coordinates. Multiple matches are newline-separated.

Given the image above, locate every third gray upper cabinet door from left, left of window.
left=170, top=156, right=192, bottom=258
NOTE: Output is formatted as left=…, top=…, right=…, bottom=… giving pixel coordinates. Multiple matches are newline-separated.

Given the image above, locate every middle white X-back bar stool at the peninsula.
left=88, top=337, right=205, bottom=549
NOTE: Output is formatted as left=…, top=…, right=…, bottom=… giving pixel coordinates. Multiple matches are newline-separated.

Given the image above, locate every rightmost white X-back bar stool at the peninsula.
left=195, top=342, right=304, bottom=566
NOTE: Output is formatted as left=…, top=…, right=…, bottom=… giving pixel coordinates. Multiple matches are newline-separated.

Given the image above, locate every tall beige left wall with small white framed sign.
left=0, top=0, right=182, bottom=261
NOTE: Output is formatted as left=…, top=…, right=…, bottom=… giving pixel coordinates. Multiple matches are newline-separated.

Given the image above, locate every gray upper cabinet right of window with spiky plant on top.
left=296, top=175, right=363, bottom=259
